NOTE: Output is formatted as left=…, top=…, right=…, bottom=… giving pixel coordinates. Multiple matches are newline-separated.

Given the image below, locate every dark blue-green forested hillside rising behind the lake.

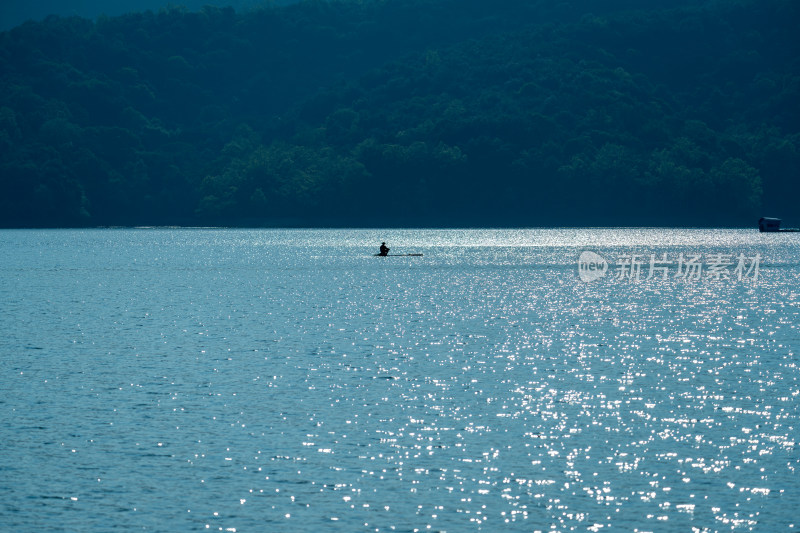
left=0, top=0, right=800, bottom=227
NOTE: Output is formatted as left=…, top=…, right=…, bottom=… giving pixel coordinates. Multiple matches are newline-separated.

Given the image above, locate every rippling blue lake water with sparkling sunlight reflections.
left=0, top=229, right=800, bottom=532
